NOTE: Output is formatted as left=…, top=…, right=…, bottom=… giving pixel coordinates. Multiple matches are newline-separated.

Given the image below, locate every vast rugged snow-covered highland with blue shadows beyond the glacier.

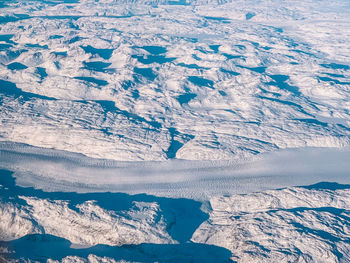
left=0, top=0, right=350, bottom=161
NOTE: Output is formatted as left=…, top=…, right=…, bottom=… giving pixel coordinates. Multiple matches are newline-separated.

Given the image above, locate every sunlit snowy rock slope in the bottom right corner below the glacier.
left=192, top=188, right=350, bottom=262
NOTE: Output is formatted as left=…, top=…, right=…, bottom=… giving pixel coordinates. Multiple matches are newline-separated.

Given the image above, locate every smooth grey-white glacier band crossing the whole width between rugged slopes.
left=0, top=143, right=350, bottom=201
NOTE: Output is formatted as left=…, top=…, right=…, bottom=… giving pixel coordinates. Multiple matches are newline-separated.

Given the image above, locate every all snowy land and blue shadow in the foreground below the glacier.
left=0, top=164, right=350, bottom=262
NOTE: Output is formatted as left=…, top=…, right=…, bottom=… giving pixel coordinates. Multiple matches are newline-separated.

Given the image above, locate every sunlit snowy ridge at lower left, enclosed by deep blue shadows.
left=0, top=197, right=174, bottom=246
